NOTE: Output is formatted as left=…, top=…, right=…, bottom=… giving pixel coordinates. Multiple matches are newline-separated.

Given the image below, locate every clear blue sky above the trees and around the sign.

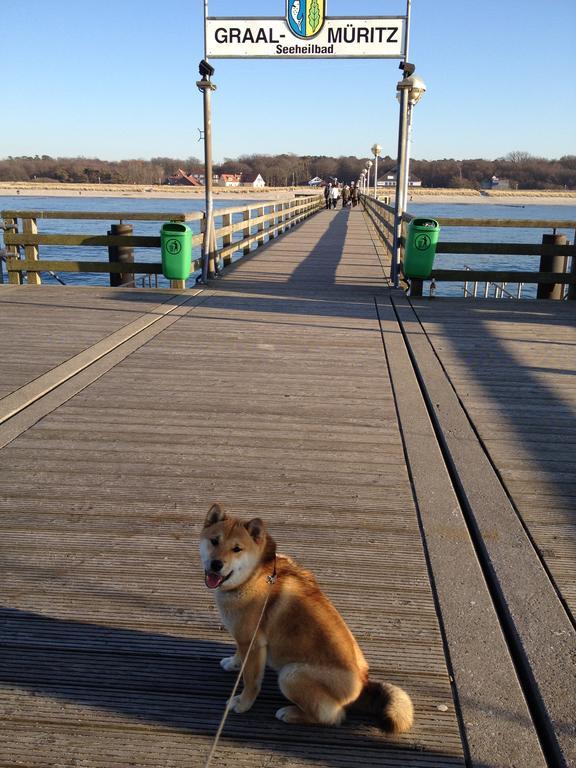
left=0, top=0, right=576, bottom=161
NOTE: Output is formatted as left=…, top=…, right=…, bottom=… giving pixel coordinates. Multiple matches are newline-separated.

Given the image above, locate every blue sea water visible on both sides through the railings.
left=0, top=195, right=576, bottom=298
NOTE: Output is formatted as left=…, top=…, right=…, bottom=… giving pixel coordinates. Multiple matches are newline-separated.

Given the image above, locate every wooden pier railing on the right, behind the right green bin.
left=362, top=196, right=576, bottom=299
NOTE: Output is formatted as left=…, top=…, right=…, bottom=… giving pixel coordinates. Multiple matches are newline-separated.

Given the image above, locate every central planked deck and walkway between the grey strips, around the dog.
left=0, top=211, right=464, bottom=768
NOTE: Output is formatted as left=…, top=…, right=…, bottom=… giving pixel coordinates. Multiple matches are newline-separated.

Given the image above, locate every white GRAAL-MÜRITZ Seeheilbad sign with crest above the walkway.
left=206, top=17, right=406, bottom=59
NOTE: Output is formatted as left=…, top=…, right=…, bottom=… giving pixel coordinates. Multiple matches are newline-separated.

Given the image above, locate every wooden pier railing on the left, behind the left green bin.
left=0, top=195, right=324, bottom=288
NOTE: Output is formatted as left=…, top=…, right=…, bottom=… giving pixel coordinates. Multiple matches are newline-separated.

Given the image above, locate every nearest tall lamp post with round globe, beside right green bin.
left=390, top=62, right=426, bottom=288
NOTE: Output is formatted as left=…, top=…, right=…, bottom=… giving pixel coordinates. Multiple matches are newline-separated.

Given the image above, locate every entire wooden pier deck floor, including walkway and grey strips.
left=0, top=208, right=576, bottom=768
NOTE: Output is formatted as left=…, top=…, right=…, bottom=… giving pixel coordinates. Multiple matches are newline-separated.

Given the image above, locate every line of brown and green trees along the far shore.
left=0, top=151, right=576, bottom=189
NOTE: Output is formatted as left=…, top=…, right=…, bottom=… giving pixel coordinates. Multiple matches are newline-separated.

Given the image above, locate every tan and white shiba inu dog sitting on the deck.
left=200, top=504, right=413, bottom=733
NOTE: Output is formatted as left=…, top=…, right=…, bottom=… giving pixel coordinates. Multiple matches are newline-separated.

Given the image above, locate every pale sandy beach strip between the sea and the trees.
left=0, top=182, right=576, bottom=205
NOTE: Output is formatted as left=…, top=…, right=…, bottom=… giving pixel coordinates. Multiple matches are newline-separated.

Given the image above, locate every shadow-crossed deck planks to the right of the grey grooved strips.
left=410, top=300, right=576, bottom=618
